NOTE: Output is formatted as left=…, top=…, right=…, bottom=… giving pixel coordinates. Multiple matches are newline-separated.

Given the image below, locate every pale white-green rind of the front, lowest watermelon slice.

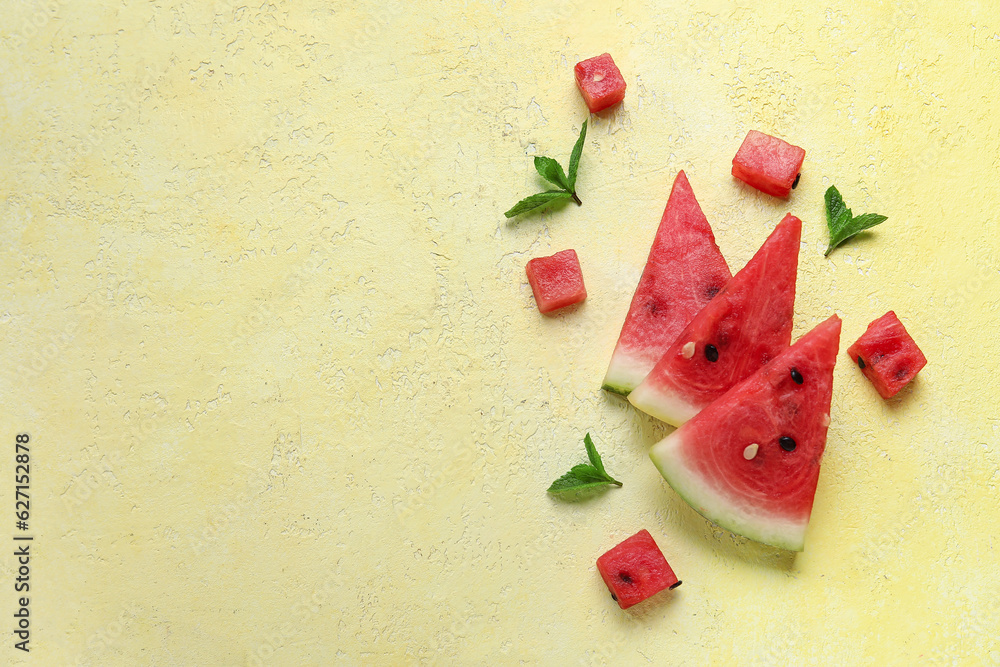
left=649, top=431, right=809, bottom=551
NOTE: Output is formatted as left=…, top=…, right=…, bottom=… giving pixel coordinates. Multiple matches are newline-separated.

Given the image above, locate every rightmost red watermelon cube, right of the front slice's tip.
left=847, top=310, right=927, bottom=398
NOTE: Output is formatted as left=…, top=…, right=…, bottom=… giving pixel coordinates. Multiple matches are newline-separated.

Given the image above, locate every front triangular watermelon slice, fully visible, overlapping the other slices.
left=649, top=315, right=840, bottom=551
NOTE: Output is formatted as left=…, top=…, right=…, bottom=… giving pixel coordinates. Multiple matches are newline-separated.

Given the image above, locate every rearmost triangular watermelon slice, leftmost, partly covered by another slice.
left=604, top=171, right=732, bottom=396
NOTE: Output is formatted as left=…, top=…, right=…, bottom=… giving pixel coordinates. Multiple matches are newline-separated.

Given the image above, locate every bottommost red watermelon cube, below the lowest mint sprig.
left=597, top=529, right=681, bottom=609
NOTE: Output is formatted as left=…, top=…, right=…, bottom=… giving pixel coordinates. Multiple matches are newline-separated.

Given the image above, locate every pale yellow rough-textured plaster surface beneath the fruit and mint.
left=0, top=0, right=1000, bottom=665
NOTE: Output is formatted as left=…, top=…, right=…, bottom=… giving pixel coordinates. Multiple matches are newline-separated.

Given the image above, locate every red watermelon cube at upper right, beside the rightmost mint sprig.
left=733, top=130, right=806, bottom=198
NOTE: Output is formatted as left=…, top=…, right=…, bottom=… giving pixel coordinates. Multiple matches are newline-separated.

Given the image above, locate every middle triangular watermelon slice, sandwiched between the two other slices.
left=628, top=214, right=802, bottom=426
